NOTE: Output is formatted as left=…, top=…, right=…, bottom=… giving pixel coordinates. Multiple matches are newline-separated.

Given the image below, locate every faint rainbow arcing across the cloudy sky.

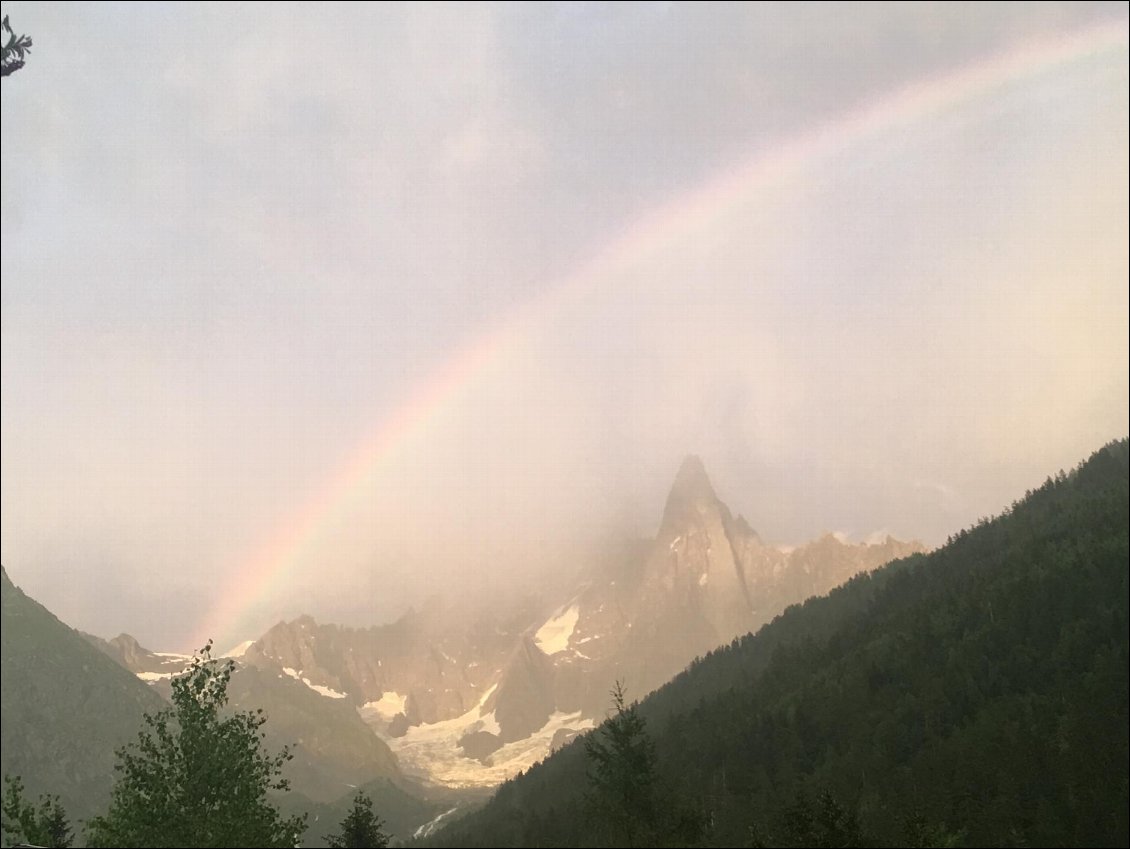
left=193, top=24, right=1128, bottom=648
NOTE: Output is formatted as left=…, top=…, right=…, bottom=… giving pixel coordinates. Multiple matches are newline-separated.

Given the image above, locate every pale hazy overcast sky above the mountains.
left=0, top=2, right=1130, bottom=649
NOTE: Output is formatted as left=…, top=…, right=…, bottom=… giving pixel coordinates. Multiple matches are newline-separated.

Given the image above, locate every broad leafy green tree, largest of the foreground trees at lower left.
left=88, top=640, right=306, bottom=847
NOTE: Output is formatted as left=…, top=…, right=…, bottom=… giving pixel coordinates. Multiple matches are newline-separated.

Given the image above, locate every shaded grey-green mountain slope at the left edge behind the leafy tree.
left=0, top=571, right=164, bottom=822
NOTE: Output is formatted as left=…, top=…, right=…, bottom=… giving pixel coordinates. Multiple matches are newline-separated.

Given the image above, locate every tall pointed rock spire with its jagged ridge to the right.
left=553, top=457, right=922, bottom=716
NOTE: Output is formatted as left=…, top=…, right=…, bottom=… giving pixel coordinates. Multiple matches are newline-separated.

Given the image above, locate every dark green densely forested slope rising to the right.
left=438, top=440, right=1130, bottom=846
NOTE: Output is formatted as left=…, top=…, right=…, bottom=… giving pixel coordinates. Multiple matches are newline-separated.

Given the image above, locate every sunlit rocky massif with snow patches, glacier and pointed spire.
left=224, top=457, right=921, bottom=785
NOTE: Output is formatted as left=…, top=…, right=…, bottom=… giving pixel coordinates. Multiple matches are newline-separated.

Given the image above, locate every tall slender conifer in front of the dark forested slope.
left=584, top=682, right=657, bottom=847
